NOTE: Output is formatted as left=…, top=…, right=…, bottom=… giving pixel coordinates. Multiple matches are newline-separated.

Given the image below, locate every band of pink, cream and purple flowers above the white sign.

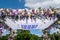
left=0, top=8, right=56, bottom=21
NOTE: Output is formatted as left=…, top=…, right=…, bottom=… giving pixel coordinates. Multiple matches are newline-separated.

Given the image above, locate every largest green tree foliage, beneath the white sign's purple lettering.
left=16, top=30, right=40, bottom=40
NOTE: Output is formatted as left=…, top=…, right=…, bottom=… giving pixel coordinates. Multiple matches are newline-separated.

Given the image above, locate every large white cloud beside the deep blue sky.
left=25, top=0, right=60, bottom=8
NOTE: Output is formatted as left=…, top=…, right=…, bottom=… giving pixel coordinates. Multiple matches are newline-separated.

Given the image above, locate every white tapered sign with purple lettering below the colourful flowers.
left=5, top=18, right=57, bottom=30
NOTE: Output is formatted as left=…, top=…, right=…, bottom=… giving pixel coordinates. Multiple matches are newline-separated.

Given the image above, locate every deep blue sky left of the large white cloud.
left=0, top=0, right=25, bottom=9
